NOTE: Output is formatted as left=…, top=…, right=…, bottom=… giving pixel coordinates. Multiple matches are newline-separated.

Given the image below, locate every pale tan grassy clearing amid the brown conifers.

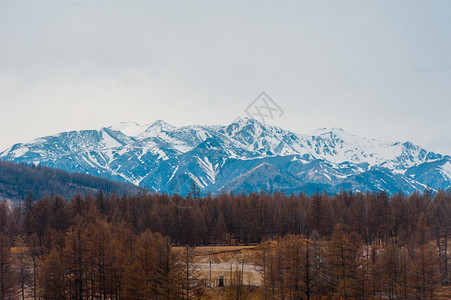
left=173, top=245, right=263, bottom=286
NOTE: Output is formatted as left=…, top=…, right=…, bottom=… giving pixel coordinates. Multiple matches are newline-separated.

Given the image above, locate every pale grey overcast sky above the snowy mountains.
left=0, top=0, right=451, bottom=154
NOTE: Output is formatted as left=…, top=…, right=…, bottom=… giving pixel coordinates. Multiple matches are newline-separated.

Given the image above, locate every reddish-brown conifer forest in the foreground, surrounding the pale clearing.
left=0, top=191, right=451, bottom=299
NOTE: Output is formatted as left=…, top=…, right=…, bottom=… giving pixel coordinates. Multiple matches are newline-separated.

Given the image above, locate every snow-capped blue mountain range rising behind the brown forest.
left=0, top=119, right=451, bottom=195
